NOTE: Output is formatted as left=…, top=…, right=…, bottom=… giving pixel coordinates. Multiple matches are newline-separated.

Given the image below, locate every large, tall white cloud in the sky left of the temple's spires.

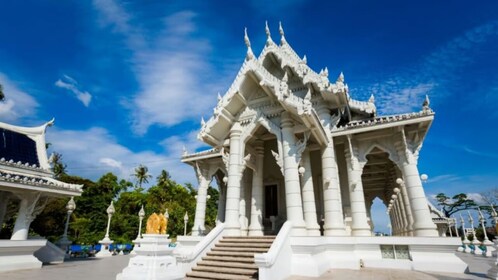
left=94, top=0, right=220, bottom=135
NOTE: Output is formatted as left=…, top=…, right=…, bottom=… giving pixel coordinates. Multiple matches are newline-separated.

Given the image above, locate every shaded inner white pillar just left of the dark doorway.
left=249, top=141, right=265, bottom=236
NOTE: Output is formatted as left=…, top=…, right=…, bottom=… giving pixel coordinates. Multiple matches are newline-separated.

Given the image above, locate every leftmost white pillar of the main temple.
left=192, top=164, right=209, bottom=236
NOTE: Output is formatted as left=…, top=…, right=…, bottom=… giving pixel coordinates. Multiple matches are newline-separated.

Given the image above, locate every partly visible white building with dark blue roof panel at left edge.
left=0, top=120, right=82, bottom=271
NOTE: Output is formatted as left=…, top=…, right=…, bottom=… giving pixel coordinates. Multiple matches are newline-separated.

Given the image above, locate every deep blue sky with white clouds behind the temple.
left=0, top=0, right=498, bottom=232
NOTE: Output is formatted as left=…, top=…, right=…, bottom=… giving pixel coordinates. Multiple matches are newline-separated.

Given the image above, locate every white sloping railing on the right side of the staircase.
left=254, top=221, right=292, bottom=280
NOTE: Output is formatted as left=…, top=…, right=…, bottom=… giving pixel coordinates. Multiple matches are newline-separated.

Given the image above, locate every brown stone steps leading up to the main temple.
left=185, top=236, right=275, bottom=280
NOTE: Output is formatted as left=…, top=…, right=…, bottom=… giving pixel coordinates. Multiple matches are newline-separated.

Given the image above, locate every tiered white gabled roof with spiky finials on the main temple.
left=182, top=25, right=434, bottom=162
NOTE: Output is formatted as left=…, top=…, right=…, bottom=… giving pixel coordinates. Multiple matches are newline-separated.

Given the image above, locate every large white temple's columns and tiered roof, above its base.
left=182, top=26, right=438, bottom=237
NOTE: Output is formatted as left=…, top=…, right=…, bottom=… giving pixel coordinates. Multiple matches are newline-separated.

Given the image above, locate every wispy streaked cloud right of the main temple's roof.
left=352, top=21, right=498, bottom=114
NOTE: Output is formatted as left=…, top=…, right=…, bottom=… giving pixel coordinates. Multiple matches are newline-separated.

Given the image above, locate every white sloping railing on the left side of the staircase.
left=175, top=223, right=225, bottom=273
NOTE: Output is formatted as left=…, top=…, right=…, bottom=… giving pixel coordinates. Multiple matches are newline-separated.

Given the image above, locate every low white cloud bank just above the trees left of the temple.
left=47, top=127, right=198, bottom=185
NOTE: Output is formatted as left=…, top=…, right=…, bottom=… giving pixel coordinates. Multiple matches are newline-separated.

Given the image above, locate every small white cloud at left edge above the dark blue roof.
left=0, top=73, right=38, bottom=122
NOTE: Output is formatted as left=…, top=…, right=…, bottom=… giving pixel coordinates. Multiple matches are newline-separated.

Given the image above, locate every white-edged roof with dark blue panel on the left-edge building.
left=0, top=120, right=83, bottom=196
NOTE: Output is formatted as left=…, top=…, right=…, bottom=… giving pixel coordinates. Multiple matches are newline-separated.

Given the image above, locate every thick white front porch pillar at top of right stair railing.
left=281, top=112, right=307, bottom=236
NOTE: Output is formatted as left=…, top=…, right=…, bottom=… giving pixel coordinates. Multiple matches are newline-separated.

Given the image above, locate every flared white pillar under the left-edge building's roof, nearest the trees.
left=10, top=193, right=41, bottom=240
